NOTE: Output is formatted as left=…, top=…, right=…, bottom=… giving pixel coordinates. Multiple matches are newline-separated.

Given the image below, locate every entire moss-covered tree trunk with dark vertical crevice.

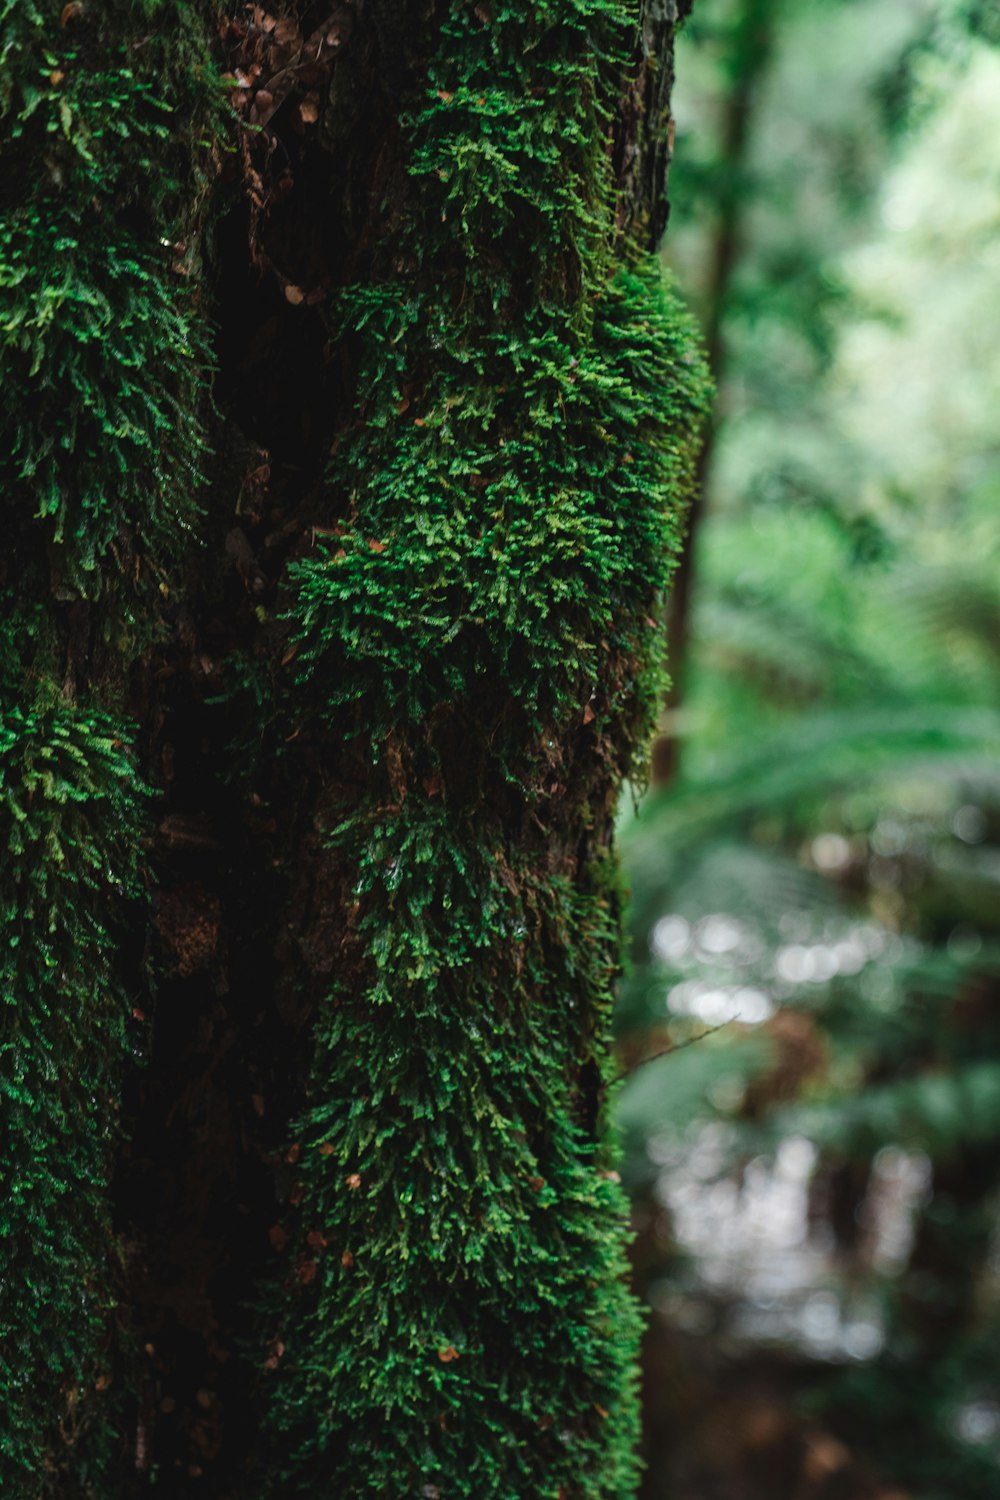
left=0, top=0, right=705, bottom=1500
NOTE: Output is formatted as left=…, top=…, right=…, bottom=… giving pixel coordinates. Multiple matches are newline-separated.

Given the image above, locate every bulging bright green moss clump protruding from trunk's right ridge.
left=289, top=266, right=706, bottom=762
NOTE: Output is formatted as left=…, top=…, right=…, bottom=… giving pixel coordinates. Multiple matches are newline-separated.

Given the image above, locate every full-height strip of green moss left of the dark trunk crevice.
left=0, top=0, right=217, bottom=1482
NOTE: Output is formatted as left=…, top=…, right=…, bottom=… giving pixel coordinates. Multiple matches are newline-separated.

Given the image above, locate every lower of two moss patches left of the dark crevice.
left=0, top=705, right=142, bottom=1500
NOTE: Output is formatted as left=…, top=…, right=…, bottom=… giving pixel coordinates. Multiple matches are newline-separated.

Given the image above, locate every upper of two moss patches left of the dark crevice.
left=0, top=5, right=217, bottom=597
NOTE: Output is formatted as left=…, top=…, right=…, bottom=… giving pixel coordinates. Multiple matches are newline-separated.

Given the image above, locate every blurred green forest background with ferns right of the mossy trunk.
left=618, top=0, right=1000, bottom=1500
